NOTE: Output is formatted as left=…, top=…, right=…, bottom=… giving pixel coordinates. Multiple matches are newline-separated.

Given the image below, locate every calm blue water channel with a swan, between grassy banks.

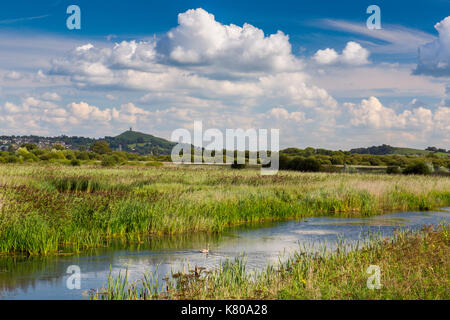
left=0, top=208, right=450, bottom=299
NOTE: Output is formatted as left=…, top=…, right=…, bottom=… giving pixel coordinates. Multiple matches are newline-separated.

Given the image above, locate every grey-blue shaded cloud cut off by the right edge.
left=414, top=16, right=450, bottom=77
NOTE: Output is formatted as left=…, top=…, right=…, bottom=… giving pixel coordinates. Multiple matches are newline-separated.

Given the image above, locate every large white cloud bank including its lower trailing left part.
left=50, top=9, right=302, bottom=85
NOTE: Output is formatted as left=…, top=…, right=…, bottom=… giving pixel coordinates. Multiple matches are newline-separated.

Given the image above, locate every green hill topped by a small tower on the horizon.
left=104, top=130, right=176, bottom=155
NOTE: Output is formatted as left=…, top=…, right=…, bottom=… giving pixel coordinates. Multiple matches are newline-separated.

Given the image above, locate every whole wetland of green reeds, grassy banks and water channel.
left=0, top=164, right=450, bottom=299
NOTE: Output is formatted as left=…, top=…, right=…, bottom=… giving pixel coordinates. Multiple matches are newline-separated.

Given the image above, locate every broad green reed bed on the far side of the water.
left=0, top=165, right=450, bottom=255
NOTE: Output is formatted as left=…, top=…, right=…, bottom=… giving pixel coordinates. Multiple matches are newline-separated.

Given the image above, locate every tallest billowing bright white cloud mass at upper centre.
left=159, top=9, right=300, bottom=71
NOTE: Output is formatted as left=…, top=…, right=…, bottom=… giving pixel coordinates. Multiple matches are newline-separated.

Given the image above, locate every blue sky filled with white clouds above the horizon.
left=0, top=0, right=450, bottom=150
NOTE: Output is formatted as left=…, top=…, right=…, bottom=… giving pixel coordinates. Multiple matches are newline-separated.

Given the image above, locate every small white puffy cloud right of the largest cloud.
left=313, top=41, right=370, bottom=66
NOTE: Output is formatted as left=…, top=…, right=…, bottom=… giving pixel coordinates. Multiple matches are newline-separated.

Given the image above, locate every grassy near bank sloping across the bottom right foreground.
left=91, top=226, right=450, bottom=300
